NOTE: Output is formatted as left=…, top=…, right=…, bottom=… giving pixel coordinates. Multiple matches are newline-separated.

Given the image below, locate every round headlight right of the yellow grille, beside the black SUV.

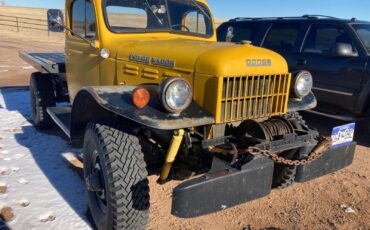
left=293, top=71, right=313, bottom=98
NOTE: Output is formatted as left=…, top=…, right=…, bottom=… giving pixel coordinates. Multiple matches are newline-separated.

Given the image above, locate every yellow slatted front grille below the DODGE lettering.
left=221, top=74, right=291, bottom=122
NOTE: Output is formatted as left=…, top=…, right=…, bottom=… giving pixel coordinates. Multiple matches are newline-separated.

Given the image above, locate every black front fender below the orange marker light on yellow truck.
left=72, top=86, right=215, bottom=137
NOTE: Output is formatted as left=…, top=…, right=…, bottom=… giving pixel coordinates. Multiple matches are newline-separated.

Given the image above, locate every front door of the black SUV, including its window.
left=296, top=23, right=366, bottom=111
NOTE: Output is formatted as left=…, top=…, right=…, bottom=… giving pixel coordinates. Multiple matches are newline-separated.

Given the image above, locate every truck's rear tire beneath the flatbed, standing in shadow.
left=30, top=73, right=56, bottom=129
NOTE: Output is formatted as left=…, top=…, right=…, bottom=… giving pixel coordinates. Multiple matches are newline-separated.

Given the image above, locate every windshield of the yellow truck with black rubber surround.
left=103, top=0, right=213, bottom=37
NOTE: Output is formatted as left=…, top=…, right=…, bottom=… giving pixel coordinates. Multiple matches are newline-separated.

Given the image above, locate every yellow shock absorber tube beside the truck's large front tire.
left=160, top=129, right=185, bottom=182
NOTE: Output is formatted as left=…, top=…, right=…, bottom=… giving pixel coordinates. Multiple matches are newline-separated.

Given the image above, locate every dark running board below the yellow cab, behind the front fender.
left=47, top=106, right=72, bottom=138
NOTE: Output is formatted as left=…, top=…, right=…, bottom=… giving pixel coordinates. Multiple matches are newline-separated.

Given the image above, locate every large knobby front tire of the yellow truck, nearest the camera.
left=83, top=122, right=149, bottom=230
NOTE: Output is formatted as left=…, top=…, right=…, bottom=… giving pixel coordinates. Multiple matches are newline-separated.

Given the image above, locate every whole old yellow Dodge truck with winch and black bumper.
left=20, top=0, right=356, bottom=229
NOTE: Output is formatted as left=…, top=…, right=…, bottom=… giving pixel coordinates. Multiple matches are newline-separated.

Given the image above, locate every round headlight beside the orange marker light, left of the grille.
left=160, top=77, right=193, bottom=113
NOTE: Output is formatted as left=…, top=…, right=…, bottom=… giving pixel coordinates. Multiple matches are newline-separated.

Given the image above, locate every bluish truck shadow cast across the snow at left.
left=0, top=88, right=89, bottom=226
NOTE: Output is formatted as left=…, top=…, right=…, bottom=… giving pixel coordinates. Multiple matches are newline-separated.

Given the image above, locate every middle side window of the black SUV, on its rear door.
left=262, top=23, right=301, bottom=53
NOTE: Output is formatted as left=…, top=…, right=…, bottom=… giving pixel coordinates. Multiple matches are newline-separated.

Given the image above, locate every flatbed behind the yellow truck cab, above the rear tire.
left=19, top=52, right=66, bottom=74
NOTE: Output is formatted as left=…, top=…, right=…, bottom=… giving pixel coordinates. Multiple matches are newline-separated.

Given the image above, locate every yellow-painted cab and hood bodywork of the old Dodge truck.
left=66, top=0, right=290, bottom=123
